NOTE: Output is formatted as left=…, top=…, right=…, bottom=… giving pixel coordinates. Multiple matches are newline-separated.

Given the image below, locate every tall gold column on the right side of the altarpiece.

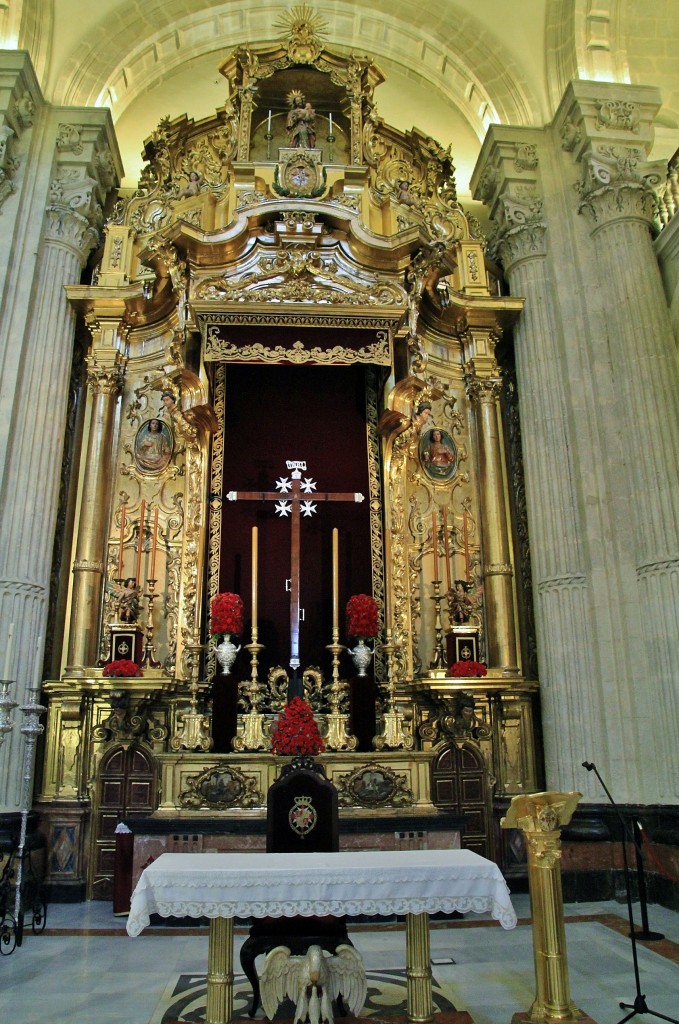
left=465, top=356, right=518, bottom=672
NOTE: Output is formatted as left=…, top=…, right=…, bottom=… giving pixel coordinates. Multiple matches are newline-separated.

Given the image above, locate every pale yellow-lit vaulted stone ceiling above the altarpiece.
left=0, top=0, right=679, bottom=198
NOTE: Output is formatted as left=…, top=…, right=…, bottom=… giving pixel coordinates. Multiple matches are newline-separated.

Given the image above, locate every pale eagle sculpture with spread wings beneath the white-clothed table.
left=260, top=945, right=367, bottom=1024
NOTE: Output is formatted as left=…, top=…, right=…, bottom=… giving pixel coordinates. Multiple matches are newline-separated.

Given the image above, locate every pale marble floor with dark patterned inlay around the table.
left=0, top=895, right=679, bottom=1024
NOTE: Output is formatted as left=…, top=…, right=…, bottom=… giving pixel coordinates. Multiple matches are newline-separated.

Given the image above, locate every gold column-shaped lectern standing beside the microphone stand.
left=501, top=793, right=591, bottom=1024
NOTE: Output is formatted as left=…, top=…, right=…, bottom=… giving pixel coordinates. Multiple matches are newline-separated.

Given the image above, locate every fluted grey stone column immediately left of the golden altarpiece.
left=0, top=109, right=120, bottom=812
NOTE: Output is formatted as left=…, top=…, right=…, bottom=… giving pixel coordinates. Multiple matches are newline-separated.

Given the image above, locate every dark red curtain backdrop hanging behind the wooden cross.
left=214, top=365, right=372, bottom=750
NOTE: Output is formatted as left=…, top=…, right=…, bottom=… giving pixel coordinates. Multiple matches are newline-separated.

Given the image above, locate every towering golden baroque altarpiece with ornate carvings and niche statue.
left=39, top=8, right=539, bottom=898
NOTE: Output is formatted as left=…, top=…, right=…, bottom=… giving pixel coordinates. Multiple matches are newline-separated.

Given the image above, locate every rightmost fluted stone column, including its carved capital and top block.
left=557, top=83, right=679, bottom=800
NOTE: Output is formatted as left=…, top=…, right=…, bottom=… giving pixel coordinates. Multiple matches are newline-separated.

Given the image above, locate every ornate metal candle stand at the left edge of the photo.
left=0, top=679, right=47, bottom=956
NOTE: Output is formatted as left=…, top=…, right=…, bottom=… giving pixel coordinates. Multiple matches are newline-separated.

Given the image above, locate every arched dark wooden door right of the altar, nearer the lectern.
left=431, top=743, right=494, bottom=860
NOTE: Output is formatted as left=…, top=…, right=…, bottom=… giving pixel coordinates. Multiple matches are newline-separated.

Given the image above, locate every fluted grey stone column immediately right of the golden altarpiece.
left=476, top=134, right=599, bottom=786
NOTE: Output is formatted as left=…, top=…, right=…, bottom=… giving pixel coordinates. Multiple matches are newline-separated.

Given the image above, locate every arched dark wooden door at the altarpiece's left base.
left=90, top=746, right=157, bottom=900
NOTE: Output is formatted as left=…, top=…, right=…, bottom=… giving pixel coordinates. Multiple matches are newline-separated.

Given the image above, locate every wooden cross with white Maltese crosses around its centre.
left=226, top=461, right=364, bottom=678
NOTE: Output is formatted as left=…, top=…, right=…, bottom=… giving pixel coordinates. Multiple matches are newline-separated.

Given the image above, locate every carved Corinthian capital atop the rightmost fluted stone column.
left=576, top=145, right=654, bottom=225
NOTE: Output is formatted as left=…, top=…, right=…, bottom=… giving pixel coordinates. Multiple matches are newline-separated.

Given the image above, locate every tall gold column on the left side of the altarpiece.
left=66, top=348, right=122, bottom=675
